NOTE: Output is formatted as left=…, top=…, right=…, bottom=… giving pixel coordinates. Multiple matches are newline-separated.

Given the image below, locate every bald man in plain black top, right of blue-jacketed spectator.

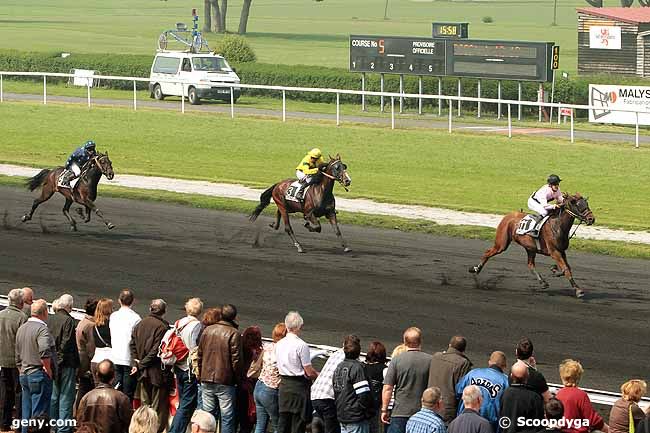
left=499, top=361, right=544, bottom=433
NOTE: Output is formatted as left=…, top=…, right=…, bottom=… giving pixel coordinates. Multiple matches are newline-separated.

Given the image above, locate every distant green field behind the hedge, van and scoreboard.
left=0, top=0, right=592, bottom=72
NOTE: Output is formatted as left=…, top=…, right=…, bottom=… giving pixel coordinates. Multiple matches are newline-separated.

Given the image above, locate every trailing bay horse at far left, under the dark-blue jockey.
left=21, top=152, right=115, bottom=231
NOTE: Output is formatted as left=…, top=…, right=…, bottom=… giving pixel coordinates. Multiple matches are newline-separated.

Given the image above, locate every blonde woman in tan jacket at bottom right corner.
left=609, top=379, right=648, bottom=433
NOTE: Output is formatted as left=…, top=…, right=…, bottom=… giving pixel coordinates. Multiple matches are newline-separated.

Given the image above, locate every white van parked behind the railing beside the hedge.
left=149, top=51, right=241, bottom=104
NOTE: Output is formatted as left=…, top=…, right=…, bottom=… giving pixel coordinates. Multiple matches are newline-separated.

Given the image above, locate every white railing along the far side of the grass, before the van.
left=0, top=71, right=641, bottom=148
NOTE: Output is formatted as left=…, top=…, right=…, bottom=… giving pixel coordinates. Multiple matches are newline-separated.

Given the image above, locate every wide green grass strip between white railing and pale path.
left=0, top=103, right=650, bottom=230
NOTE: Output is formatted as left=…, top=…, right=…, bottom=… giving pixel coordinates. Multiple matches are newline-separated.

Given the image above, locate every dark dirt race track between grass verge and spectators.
left=0, top=187, right=650, bottom=391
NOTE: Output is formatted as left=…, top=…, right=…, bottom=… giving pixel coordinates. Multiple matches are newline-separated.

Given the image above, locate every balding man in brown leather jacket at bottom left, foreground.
left=77, top=359, right=133, bottom=433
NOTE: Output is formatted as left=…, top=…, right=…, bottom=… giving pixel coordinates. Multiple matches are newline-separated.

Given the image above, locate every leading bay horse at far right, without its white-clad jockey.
left=469, top=193, right=596, bottom=298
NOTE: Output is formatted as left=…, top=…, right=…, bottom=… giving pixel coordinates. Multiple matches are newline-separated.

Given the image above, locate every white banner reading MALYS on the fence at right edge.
left=589, top=84, right=650, bottom=125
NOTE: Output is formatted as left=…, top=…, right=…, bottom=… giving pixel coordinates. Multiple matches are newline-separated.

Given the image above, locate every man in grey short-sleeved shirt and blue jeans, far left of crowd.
left=16, top=299, right=57, bottom=433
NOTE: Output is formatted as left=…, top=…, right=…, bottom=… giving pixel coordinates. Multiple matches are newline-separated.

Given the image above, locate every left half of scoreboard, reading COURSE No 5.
left=350, top=36, right=447, bottom=76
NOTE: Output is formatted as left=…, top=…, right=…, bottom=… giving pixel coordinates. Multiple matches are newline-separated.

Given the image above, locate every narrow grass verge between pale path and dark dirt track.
left=0, top=175, right=650, bottom=260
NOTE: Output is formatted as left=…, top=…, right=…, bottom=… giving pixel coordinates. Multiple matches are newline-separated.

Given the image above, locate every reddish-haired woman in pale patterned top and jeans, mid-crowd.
left=253, top=323, right=287, bottom=433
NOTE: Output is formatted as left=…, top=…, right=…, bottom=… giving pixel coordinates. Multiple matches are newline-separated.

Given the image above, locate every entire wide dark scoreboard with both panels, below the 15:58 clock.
left=350, top=36, right=554, bottom=82
